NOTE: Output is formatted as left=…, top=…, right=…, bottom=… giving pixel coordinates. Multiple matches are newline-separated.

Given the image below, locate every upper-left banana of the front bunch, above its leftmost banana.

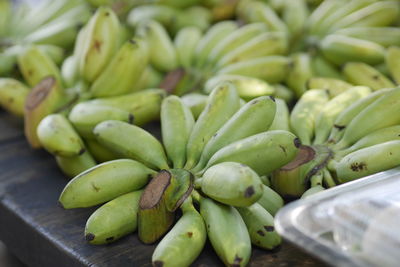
left=93, top=120, right=169, bottom=170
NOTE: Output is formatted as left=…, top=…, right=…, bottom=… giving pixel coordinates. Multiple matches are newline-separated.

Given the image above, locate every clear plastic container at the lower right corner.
left=275, top=167, right=400, bottom=267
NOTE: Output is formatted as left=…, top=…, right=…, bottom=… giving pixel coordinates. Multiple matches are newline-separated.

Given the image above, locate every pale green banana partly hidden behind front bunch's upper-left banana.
left=68, top=102, right=134, bottom=139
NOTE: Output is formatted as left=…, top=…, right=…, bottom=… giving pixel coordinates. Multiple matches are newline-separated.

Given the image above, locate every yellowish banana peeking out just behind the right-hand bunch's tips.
left=307, top=77, right=353, bottom=98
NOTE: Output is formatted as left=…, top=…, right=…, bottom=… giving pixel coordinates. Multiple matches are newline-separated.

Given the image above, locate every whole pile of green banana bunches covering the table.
left=0, top=0, right=400, bottom=266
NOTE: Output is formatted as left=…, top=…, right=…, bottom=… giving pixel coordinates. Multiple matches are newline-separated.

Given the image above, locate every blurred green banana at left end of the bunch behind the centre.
left=136, top=21, right=178, bottom=72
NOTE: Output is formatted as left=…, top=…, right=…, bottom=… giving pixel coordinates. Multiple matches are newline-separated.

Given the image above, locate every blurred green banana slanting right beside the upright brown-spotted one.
left=90, top=39, right=148, bottom=98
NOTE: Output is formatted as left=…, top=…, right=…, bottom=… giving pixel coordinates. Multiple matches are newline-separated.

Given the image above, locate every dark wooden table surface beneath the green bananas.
left=0, top=112, right=326, bottom=267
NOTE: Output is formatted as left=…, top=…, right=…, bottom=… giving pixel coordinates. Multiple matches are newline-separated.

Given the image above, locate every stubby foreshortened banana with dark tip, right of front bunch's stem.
left=195, top=162, right=264, bottom=207
